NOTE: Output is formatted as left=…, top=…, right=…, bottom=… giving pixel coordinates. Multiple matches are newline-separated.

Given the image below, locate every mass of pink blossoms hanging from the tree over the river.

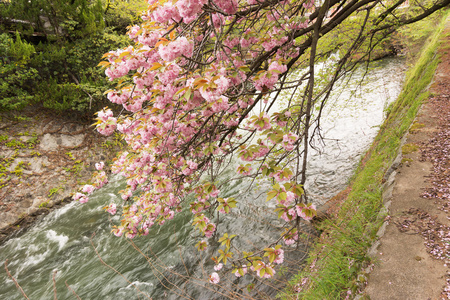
left=81, top=0, right=320, bottom=284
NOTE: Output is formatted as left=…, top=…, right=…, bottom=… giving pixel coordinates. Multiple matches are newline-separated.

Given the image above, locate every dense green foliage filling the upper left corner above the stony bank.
left=0, top=0, right=144, bottom=112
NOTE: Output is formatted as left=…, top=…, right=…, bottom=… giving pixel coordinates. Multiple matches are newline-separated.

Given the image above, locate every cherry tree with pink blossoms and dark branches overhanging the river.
left=74, top=0, right=449, bottom=284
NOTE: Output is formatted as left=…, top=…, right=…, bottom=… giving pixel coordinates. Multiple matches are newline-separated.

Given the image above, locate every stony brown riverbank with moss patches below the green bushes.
left=0, top=107, right=120, bottom=244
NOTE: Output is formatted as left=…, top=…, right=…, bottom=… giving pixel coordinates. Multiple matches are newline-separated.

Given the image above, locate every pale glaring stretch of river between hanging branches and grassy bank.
left=306, top=57, right=405, bottom=204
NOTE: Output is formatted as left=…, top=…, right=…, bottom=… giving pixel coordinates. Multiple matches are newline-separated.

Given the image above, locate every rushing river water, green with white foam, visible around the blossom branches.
left=0, top=59, right=403, bottom=299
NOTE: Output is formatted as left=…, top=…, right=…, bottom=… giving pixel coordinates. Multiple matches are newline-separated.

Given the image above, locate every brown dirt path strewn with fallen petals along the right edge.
left=365, top=22, right=450, bottom=300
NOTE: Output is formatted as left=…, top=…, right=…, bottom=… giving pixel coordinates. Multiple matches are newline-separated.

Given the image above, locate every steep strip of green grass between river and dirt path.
left=284, top=11, right=449, bottom=300
